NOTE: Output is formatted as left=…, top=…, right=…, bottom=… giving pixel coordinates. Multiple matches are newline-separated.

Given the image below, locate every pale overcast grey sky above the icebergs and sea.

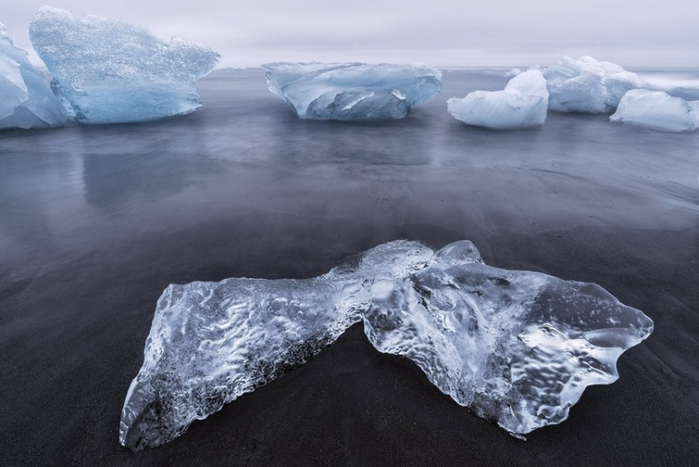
left=0, top=0, right=699, bottom=68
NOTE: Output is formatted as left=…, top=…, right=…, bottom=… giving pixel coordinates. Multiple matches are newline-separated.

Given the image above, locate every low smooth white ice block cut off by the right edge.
left=609, top=89, right=699, bottom=132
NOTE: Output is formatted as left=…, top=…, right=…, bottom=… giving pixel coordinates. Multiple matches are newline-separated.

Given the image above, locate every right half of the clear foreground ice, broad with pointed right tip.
left=364, top=242, right=653, bottom=435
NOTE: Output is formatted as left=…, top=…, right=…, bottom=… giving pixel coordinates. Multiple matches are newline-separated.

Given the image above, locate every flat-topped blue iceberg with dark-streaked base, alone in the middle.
left=262, top=62, right=442, bottom=120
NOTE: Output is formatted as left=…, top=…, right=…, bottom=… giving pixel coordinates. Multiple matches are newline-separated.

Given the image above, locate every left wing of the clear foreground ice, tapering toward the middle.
left=119, top=242, right=432, bottom=450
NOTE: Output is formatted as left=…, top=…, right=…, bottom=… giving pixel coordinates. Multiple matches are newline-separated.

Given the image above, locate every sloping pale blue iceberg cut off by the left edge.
left=0, top=23, right=66, bottom=130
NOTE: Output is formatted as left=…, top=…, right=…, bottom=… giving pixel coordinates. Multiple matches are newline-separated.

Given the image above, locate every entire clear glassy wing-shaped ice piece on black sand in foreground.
left=119, top=240, right=653, bottom=450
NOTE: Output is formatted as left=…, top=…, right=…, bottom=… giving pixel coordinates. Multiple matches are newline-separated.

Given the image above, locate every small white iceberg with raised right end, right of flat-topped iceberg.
left=447, top=70, right=549, bottom=130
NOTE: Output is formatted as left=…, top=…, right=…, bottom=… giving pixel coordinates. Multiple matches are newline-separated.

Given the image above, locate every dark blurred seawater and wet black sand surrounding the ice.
left=0, top=69, right=699, bottom=466
